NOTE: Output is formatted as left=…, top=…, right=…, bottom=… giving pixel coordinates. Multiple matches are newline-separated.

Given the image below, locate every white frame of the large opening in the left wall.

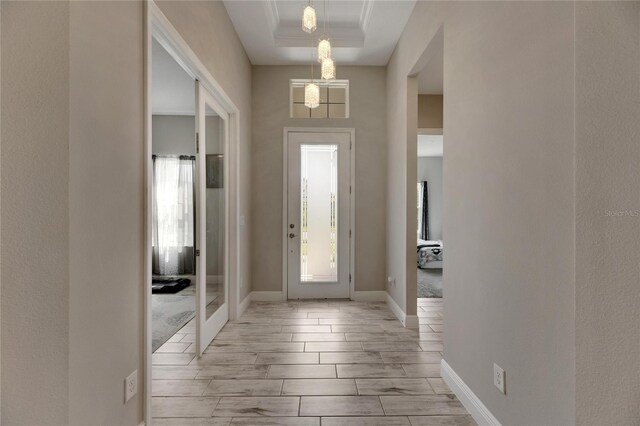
left=141, top=0, right=242, bottom=425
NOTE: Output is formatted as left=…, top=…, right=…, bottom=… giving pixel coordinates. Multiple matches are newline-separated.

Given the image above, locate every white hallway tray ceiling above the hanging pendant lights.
left=224, top=0, right=416, bottom=65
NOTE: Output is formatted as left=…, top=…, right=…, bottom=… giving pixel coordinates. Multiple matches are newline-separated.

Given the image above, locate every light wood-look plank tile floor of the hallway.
left=152, top=299, right=475, bottom=426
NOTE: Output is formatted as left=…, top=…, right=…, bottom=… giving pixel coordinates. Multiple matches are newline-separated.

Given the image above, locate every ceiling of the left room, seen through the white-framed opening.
left=152, top=39, right=196, bottom=115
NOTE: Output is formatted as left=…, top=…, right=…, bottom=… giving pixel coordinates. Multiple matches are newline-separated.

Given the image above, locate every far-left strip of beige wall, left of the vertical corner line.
left=0, top=2, right=69, bottom=425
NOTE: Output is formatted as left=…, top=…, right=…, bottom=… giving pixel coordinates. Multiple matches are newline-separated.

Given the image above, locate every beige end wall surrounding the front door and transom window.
left=251, top=66, right=386, bottom=291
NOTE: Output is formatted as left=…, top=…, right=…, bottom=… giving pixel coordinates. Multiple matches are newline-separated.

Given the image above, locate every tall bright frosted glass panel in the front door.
left=300, top=145, right=338, bottom=282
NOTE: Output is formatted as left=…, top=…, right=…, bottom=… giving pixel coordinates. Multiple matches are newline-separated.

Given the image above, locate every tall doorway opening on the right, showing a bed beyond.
left=408, top=28, right=446, bottom=351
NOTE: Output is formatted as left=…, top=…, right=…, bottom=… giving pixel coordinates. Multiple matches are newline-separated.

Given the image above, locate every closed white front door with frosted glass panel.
left=285, top=131, right=352, bottom=299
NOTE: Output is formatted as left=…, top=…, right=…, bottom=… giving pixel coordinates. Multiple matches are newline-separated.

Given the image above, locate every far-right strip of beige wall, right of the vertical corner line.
left=575, top=1, right=640, bottom=425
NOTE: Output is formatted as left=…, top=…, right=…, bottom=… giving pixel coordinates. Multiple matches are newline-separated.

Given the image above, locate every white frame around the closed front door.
left=282, top=127, right=356, bottom=300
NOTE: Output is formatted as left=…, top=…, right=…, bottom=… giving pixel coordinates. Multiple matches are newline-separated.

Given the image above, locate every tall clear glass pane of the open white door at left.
left=205, top=105, right=227, bottom=319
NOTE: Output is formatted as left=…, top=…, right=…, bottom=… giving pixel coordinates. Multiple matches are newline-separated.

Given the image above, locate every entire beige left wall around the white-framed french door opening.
left=0, top=2, right=251, bottom=425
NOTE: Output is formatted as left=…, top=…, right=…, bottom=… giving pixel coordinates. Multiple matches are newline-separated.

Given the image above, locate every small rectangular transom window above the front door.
left=289, top=79, right=349, bottom=118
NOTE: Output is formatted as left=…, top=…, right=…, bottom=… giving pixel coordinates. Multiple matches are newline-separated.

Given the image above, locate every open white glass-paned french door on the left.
left=196, top=81, right=229, bottom=355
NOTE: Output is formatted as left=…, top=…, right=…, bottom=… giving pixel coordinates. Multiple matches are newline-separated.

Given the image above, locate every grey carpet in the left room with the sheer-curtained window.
left=151, top=292, right=196, bottom=352
